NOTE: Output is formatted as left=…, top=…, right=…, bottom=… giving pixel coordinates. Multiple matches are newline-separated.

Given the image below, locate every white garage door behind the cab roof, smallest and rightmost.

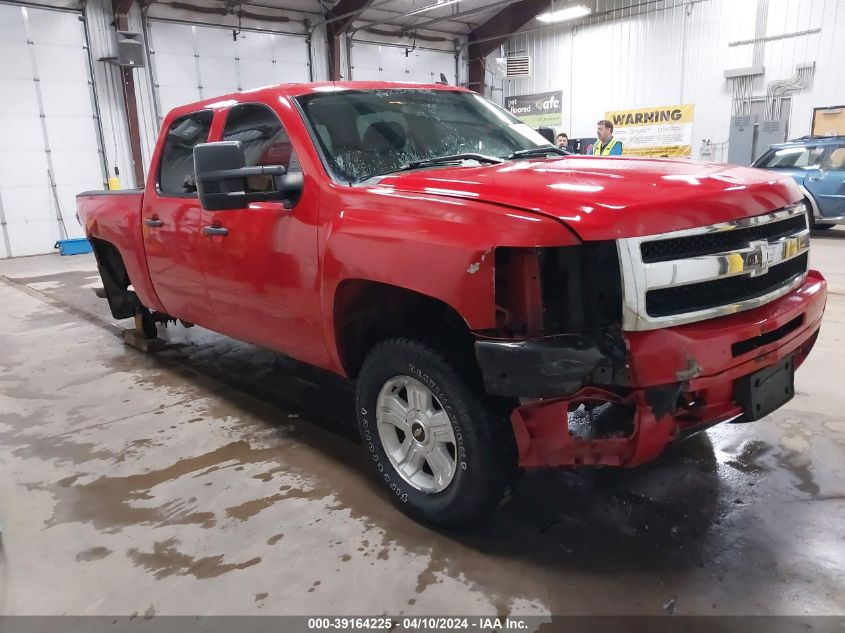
left=351, top=42, right=455, bottom=84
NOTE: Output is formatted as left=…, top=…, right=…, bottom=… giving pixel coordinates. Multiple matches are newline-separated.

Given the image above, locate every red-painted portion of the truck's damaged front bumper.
left=511, top=271, right=827, bottom=468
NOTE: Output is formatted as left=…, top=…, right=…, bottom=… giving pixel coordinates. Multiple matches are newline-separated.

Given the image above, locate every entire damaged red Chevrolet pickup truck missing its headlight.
left=78, top=83, right=826, bottom=525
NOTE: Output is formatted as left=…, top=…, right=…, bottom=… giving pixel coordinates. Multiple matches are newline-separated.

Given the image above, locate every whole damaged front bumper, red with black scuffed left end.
left=476, top=271, right=827, bottom=468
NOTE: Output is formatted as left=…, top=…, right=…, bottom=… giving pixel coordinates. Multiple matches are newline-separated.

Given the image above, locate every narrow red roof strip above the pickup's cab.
left=165, top=81, right=469, bottom=116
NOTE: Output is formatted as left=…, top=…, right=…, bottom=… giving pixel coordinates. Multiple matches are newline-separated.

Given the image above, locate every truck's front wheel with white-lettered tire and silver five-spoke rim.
left=356, top=338, right=518, bottom=527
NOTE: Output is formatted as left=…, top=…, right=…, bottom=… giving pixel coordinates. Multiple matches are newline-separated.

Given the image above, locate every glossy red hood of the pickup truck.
left=378, top=156, right=802, bottom=241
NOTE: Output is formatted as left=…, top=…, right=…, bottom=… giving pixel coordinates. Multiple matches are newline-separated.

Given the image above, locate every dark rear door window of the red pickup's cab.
left=158, top=110, right=214, bottom=196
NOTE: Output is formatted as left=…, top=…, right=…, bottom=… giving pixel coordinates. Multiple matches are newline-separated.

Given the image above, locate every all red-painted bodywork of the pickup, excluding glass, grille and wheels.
left=78, top=82, right=825, bottom=465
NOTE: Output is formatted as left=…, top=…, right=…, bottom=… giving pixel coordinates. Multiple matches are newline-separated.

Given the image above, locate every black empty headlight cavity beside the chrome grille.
left=541, top=242, right=622, bottom=333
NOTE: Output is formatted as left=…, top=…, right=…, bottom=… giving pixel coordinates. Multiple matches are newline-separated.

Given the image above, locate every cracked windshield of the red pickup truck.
left=298, top=89, right=558, bottom=184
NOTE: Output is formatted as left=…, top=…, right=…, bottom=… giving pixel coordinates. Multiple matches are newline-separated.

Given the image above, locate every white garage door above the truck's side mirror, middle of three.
left=149, top=18, right=310, bottom=114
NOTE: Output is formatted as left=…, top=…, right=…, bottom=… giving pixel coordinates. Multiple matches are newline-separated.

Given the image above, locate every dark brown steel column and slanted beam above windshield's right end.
left=468, top=0, right=552, bottom=94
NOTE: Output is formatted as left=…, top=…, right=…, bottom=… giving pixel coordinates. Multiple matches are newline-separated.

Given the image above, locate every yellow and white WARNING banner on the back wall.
left=605, top=104, right=695, bottom=157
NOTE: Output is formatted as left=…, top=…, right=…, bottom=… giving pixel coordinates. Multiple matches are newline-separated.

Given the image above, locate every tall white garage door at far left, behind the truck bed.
left=0, top=4, right=104, bottom=257
